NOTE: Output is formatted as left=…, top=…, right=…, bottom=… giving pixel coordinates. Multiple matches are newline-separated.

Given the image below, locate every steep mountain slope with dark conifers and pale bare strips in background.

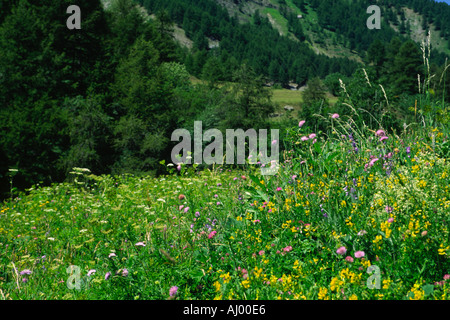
left=137, top=0, right=450, bottom=87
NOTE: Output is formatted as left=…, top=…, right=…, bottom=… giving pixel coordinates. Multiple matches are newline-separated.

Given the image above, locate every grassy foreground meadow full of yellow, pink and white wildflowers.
left=0, top=102, right=450, bottom=300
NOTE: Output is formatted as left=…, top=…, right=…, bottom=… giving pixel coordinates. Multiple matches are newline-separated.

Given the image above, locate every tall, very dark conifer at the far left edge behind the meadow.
left=0, top=0, right=109, bottom=190
